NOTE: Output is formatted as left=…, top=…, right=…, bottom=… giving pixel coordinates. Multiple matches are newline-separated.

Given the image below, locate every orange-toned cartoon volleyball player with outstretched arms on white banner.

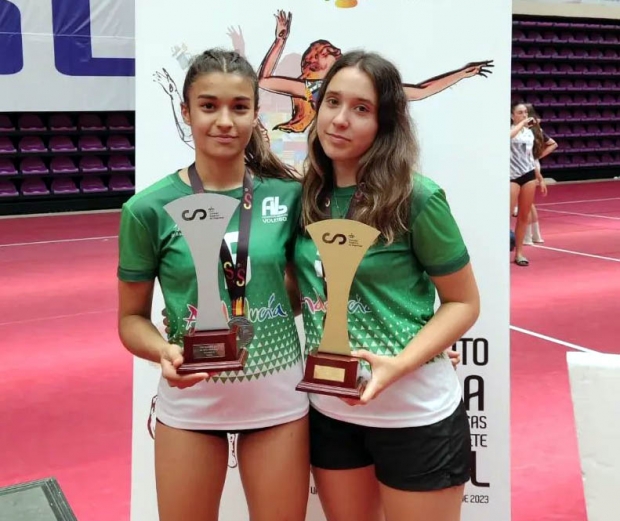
left=258, top=6, right=494, bottom=132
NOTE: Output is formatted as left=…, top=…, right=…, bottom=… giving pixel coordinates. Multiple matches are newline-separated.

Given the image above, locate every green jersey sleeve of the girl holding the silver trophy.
left=117, top=205, right=157, bottom=282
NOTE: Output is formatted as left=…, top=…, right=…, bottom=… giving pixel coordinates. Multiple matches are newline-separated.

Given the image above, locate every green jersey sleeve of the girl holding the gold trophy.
left=411, top=188, right=469, bottom=276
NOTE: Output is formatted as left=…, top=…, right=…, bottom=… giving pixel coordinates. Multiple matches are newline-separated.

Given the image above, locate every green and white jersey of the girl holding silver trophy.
left=118, top=173, right=308, bottom=430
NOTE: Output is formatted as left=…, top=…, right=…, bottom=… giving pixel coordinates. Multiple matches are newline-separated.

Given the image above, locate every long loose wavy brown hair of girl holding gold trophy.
left=302, top=51, right=419, bottom=244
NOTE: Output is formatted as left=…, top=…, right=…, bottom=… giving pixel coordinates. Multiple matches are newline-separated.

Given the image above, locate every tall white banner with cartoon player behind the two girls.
left=132, top=0, right=512, bottom=521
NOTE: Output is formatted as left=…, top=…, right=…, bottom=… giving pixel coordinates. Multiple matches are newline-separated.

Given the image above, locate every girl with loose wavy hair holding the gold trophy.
left=294, top=51, right=479, bottom=521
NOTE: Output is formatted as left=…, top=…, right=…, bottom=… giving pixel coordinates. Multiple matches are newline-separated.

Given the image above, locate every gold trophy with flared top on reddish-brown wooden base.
left=296, top=219, right=379, bottom=398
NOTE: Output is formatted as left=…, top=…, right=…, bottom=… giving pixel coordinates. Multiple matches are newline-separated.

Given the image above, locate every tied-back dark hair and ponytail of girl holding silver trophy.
left=183, top=49, right=299, bottom=180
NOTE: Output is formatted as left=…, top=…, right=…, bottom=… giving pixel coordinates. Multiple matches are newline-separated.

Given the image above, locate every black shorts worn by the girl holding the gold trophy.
left=310, top=402, right=471, bottom=492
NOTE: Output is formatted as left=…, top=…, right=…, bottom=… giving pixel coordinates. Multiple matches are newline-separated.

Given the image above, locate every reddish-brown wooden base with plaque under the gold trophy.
left=295, top=352, right=365, bottom=399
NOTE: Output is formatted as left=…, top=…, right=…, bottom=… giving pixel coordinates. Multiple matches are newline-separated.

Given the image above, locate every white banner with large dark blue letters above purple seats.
left=0, top=0, right=135, bottom=112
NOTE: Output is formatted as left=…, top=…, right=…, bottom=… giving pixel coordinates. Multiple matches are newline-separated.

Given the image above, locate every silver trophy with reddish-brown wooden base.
left=164, top=193, right=251, bottom=374
